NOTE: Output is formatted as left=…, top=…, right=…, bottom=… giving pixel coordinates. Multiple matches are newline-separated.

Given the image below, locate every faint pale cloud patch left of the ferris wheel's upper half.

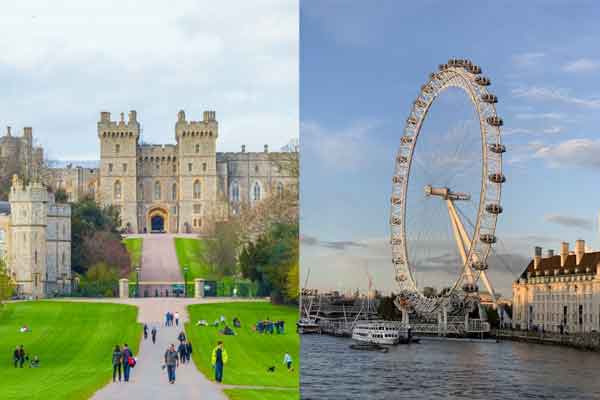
left=300, top=120, right=380, bottom=169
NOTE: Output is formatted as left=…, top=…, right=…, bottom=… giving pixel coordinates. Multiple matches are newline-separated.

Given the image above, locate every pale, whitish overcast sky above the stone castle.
left=0, top=0, right=299, bottom=160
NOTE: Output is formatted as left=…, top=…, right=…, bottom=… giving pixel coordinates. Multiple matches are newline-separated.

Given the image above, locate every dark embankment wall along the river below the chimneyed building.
left=493, top=330, right=600, bottom=351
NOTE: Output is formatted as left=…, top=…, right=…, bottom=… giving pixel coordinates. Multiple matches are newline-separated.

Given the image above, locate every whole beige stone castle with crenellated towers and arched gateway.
left=0, top=111, right=298, bottom=297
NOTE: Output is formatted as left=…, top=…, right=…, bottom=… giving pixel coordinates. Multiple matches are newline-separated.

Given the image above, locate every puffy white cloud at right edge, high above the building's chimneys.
left=533, top=139, right=600, bottom=168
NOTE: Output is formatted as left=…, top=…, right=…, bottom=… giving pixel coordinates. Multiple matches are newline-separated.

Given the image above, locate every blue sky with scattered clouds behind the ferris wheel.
left=300, top=0, right=600, bottom=297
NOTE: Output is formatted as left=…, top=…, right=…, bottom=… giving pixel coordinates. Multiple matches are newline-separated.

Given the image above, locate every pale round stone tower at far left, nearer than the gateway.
left=9, top=175, right=51, bottom=298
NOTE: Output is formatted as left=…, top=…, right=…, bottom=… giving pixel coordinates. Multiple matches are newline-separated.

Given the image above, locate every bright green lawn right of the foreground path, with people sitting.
left=186, top=302, right=300, bottom=392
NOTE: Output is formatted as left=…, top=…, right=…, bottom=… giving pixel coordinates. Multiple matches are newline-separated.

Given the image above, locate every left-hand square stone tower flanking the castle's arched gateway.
left=98, top=111, right=140, bottom=232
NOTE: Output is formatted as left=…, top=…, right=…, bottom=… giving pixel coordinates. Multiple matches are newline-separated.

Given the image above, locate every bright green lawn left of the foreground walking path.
left=0, top=301, right=142, bottom=400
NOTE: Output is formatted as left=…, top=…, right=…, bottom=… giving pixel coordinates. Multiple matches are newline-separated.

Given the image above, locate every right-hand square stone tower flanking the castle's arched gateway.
left=175, top=111, right=221, bottom=233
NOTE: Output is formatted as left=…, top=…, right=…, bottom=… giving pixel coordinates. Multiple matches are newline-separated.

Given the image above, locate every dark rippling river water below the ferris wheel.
left=300, top=335, right=600, bottom=400
